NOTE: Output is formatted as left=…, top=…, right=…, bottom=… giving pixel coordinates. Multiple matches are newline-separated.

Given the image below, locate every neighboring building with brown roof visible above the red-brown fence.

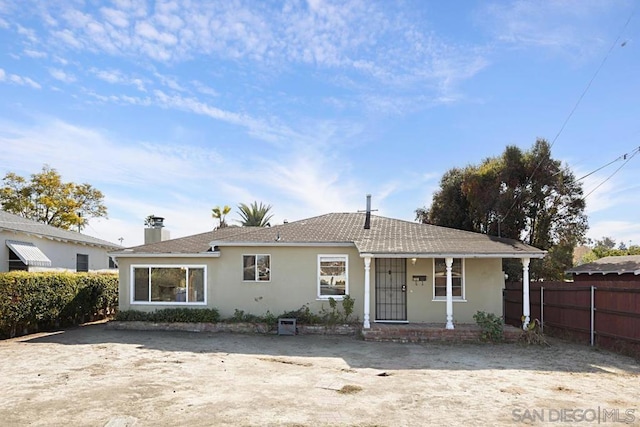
left=566, top=255, right=640, bottom=282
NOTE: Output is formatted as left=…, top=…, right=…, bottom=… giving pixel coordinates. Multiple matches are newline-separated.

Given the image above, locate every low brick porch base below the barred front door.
left=362, top=323, right=522, bottom=343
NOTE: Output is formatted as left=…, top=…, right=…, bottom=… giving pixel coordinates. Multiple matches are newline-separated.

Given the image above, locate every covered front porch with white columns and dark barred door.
left=361, top=254, right=530, bottom=332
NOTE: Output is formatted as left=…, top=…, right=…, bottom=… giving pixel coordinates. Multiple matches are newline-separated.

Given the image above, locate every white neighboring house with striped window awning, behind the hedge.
left=0, top=210, right=120, bottom=271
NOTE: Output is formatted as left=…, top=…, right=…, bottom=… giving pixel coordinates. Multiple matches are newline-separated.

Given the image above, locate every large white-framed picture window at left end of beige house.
left=131, top=266, right=206, bottom=304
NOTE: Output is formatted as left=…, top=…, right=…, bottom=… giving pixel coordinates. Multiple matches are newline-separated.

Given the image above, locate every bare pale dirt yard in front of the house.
left=0, top=324, right=640, bottom=426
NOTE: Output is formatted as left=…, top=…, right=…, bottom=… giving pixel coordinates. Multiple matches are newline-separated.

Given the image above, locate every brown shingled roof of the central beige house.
left=115, top=213, right=546, bottom=258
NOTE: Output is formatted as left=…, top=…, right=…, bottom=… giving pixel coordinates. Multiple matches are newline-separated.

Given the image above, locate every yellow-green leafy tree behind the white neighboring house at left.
left=0, top=165, right=107, bottom=230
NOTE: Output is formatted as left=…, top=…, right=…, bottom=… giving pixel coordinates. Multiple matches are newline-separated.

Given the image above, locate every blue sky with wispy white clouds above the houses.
left=0, top=0, right=640, bottom=246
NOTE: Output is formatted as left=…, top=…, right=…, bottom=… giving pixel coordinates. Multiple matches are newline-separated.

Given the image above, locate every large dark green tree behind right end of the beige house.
left=416, top=139, right=588, bottom=279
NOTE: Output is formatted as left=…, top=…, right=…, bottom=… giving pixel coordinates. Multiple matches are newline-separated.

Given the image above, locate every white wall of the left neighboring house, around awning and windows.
left=0, top=230, right=115, bottom=271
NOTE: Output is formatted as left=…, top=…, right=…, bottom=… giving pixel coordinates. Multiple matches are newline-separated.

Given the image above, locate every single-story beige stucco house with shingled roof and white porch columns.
left=112, top=204, right=546, bottom=329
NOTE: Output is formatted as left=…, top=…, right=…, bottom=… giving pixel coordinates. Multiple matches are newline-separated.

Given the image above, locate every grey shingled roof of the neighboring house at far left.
left=0, top=210, right=120, bottom=249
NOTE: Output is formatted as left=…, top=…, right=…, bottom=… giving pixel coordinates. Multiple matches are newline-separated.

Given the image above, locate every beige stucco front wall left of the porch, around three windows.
left=118, top=247, right=364, bottom=319
